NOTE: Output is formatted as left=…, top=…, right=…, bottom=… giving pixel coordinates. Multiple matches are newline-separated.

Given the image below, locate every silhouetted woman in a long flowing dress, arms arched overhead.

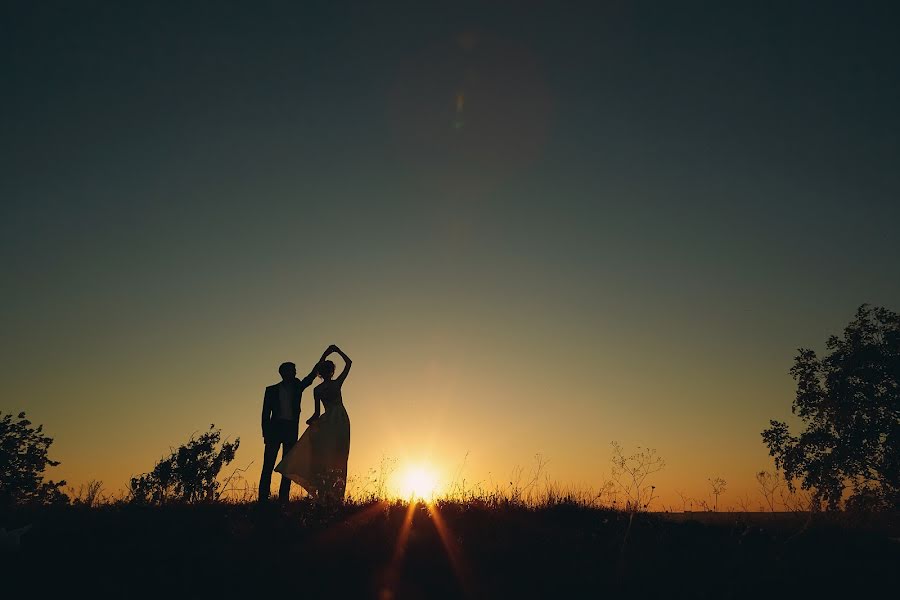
left=275, top=344, right=353, bottom=501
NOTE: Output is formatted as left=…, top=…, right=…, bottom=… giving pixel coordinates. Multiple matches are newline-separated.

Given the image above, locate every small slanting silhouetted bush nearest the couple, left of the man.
left=129, top=425, right=241, bottom=504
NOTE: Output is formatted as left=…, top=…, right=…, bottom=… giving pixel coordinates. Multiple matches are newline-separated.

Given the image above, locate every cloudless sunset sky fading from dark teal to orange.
left=0, top=0, right=900, bottom=504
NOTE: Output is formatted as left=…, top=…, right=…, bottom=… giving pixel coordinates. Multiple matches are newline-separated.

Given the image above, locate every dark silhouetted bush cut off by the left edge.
left=0, top=412, right=67, bottom=508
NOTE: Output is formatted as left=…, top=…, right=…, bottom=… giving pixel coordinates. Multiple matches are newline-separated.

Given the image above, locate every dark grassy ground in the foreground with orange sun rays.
left=0, top=502, right=900, bottom=599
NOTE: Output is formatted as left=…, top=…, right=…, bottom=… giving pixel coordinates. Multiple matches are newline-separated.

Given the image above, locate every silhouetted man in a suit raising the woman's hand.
left=259, top=363, right=316, bottom=503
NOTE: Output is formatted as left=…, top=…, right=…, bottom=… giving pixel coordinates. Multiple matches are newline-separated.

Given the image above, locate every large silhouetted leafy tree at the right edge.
left=762, top=304, right=900, bottom=510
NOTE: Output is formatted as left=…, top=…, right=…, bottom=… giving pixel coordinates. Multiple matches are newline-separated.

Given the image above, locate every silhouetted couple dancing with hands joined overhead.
left=259, top=344, right=353, bottom=503
